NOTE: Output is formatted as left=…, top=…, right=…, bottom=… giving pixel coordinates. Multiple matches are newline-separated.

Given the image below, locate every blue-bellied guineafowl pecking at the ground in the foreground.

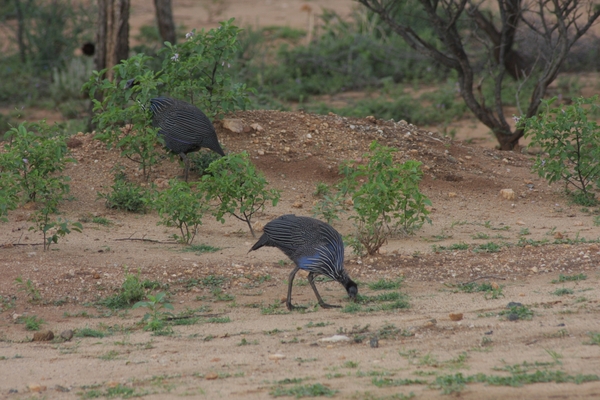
left=250, top=214, right=358, bottom=311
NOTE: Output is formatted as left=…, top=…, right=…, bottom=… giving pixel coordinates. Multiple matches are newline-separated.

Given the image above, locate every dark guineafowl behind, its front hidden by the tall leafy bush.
left=125, top=79, right=225, bottom=181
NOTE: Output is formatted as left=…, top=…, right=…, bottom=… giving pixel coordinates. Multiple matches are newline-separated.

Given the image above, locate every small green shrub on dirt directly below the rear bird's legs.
left=153, top=179, right=207, bottom=244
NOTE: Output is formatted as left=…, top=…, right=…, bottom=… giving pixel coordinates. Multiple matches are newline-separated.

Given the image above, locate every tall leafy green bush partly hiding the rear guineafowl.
left=84, top=20, right=250, bottom=179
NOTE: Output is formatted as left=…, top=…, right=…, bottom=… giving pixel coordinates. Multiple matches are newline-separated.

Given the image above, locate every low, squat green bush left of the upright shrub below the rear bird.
left=98, top=171, right=151, bottom=213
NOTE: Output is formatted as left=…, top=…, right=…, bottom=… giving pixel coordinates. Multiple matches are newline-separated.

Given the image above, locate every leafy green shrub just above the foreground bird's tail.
left=199, top=152, right=280, bottom=236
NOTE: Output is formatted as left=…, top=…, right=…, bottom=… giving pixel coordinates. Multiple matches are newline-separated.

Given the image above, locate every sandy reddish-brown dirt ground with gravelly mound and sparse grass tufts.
left=0, top=1, right=600, bottom=399
